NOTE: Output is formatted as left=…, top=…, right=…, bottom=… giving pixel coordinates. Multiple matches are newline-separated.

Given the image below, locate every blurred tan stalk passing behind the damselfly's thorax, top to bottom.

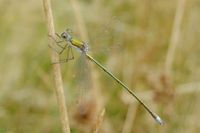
left=70, top=0, right=105, bottom=133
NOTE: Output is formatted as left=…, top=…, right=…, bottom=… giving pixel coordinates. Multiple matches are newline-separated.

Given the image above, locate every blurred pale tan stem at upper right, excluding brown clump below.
left=165, top=0, right=186, bottom=76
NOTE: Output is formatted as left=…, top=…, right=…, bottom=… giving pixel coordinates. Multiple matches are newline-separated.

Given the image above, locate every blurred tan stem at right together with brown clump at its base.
left=153, top=0, right=186, bottom=114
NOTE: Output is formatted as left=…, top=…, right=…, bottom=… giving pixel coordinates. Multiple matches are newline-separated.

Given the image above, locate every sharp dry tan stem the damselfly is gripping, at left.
left=43, top=0, right=70, bottom=133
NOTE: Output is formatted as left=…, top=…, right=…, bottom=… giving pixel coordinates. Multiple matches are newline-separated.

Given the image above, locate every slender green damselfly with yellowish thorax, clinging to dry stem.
left=48, top=30, right=164, bottom=125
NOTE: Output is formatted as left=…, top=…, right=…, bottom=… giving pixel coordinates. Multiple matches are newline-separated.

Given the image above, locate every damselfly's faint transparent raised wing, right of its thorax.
left=88, top=17, right=124, bottom=56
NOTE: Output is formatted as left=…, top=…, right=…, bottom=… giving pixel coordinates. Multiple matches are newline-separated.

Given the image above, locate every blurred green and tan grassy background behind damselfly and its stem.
left=0, top=0, right=200, bottom=133
